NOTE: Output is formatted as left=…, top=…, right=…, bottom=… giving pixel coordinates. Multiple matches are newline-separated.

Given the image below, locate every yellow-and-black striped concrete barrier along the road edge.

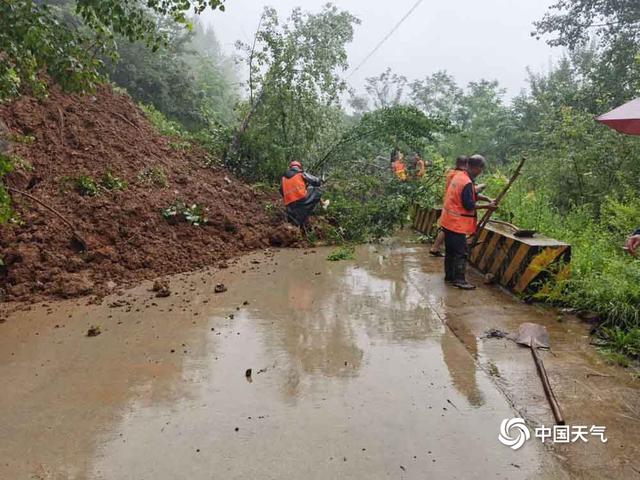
left=413, top=204, right=571, bottom=294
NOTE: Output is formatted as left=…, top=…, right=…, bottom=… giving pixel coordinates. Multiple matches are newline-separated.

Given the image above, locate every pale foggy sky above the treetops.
left=206, top=0, right=560, bottom=101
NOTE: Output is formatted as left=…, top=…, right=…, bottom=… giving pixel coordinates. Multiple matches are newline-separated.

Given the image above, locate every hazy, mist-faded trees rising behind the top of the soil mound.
left=105, top=18, right=237, bottom=131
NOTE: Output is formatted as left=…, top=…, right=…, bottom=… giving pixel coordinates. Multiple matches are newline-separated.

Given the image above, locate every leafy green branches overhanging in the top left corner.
left=0, top=0, right=229, bottom=101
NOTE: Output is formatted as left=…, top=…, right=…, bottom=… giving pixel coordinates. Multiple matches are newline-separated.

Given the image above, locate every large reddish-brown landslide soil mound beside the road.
left=0, top=83, right=297, bottom=300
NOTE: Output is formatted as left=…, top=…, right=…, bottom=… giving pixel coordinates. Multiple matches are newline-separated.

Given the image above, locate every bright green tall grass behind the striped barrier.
left=489, top=175, right=640, bottom=331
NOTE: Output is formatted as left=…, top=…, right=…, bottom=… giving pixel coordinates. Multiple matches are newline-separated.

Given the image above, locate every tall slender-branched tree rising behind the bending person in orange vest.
left=227, top=4, right=358, bottom=181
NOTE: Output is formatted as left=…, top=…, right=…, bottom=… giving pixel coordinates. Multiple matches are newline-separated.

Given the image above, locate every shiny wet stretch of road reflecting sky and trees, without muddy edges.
left=93, top=247, right=552, bottom=480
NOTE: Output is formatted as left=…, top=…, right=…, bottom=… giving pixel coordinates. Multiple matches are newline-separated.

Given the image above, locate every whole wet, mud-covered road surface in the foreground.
left=0, top=241, right=640, bottom=480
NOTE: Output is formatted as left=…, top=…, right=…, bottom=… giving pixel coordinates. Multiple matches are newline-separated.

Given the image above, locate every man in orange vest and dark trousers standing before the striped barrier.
left=440, top=155, right=497, bottom=290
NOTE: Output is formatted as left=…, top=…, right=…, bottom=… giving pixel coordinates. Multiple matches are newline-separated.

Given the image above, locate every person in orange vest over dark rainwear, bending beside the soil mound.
left=280, top=160, right=322, bottom=227
